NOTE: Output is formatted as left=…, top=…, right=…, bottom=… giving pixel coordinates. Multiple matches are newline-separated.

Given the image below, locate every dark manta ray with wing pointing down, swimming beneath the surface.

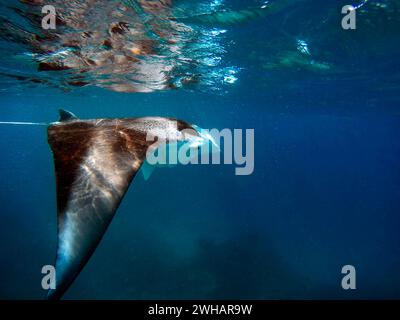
left=48, top=110, right=216, bottom=299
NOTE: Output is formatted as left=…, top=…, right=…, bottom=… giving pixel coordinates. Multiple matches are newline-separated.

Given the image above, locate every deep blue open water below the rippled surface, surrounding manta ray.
left=0, top=86, right=400, bottom=298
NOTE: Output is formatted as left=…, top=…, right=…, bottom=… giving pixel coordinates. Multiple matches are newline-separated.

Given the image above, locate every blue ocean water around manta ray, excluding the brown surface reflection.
left=0, top=0, right=400, bottom=299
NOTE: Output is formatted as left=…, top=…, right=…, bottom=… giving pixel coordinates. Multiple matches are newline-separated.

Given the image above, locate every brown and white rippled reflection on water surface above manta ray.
left=1, top=0, right=241, bottom=92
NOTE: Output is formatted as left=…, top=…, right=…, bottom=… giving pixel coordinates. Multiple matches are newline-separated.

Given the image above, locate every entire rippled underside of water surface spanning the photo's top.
left=0, top=0, right=400, bottom=101
